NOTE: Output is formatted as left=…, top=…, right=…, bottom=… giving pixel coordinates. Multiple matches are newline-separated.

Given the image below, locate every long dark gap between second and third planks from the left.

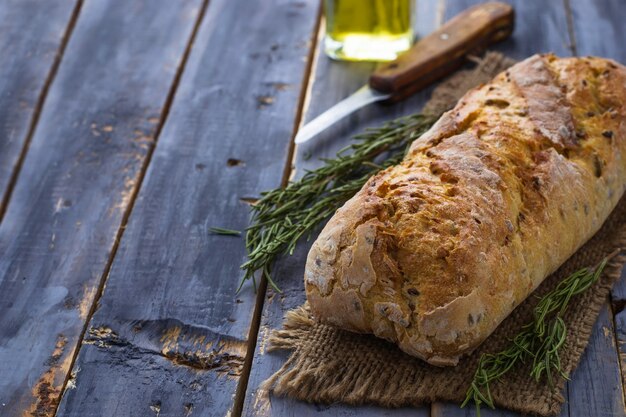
left=50, top=0, right=209, bottom=416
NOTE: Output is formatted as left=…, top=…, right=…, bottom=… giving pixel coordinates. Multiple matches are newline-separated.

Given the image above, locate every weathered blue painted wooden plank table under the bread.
left=0, top=0, right=626, bottom=417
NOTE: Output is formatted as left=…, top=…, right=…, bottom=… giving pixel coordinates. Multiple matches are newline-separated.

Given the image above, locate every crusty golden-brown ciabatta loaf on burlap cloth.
left=305, top=55, right=626, bottom=365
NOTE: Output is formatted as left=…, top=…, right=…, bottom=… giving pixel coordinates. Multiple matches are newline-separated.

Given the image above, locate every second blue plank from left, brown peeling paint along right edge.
left=0, top=0, right=200, bottom=416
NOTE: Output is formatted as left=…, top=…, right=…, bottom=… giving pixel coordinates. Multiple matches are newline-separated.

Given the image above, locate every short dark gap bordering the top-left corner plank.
left=0, top=0, right=83, bottom=222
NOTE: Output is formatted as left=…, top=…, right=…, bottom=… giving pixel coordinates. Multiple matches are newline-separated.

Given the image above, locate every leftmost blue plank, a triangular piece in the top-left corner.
left=0, top=0, right=79, bottom=219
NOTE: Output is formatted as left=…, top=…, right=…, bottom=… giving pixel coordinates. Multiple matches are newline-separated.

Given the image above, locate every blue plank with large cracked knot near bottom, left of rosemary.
left=58, top=0, right=319, bottom=417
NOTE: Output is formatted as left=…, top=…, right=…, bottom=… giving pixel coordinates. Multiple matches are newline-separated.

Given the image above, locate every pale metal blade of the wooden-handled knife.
left=295, top=85, right=391, bottom=143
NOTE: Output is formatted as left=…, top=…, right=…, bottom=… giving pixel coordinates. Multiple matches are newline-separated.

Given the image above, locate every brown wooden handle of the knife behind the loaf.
left=369, top=2, right=515, bottom=102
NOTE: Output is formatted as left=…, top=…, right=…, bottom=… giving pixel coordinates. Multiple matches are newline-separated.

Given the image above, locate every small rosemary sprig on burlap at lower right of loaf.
left=461, top=254, right=613, bottom=417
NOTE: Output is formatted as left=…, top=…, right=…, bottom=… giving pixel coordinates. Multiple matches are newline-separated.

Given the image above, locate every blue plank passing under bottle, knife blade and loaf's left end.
left=243, top=1, right=437, bottom=417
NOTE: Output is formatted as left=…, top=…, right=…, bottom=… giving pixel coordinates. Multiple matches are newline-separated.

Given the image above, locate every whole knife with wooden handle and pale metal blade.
left=295, top=2, right=515, bottom=143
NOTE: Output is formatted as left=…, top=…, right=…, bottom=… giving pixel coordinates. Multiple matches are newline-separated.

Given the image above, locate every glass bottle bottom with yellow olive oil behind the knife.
left=324, top=0, right=414, bottom=61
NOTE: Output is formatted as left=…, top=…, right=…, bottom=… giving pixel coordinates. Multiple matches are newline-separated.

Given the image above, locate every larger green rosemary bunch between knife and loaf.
left=239, top=114, right=437, bottom=291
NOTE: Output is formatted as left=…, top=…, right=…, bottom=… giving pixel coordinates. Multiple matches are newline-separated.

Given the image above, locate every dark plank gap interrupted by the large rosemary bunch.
left=230, top=1, right=324, bottom=417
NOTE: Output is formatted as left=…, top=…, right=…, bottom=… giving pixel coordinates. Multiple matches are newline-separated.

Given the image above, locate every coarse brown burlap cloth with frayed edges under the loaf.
left=264, top=53, right=626, bottom=416
